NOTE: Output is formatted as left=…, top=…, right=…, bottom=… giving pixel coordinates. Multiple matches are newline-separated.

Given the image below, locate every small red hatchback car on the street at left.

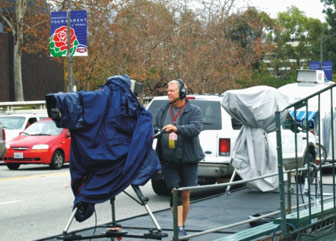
left=3, top=119, right=71, bottom=170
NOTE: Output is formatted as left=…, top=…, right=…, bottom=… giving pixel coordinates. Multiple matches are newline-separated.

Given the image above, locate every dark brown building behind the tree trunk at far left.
left=0, top=0, right=64, bottom=101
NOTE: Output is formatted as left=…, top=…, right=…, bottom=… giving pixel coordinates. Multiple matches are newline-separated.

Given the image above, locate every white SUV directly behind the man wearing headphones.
left=147, top=95, right=236, bottom=195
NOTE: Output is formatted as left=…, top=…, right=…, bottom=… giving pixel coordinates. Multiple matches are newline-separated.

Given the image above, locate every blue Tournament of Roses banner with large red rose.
left=49, top=10, right=88, bottom=57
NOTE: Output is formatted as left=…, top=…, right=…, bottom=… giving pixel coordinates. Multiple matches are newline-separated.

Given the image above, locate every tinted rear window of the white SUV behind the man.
left=148, top=99, right=222, bottom=130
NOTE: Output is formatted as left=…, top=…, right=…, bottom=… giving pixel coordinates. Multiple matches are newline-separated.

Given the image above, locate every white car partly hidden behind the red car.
left=0, top=112, right=48, bottom=141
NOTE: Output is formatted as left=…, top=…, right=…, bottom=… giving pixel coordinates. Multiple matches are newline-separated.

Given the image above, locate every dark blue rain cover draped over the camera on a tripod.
left=46, top=75, right=161, bottom=205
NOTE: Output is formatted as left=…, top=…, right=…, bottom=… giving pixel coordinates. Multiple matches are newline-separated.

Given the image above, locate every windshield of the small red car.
left=23, top=121, right=63, bottom=136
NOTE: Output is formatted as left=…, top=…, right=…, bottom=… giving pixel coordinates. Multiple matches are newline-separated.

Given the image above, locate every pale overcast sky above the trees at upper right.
left=237, top=0, right=325, bottom=22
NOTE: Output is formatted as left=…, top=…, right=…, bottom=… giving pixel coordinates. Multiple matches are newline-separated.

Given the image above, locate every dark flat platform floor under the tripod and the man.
left=41, top=185, right=331, bottom=241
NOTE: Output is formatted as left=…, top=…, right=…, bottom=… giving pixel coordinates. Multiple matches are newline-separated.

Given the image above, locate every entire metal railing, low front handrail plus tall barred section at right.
left=173, top=84, right=336, bottom=241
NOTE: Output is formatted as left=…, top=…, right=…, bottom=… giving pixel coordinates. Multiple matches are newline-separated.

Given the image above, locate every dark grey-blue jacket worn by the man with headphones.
left=155, top=99, right=205, bottom=163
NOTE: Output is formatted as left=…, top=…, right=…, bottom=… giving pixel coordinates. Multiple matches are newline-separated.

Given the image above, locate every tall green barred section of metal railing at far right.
left=275, top=84, right=336, bottom=237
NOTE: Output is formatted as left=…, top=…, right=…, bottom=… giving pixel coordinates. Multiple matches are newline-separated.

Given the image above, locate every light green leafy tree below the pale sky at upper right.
left=267, top=7, right=326, bottom=85
